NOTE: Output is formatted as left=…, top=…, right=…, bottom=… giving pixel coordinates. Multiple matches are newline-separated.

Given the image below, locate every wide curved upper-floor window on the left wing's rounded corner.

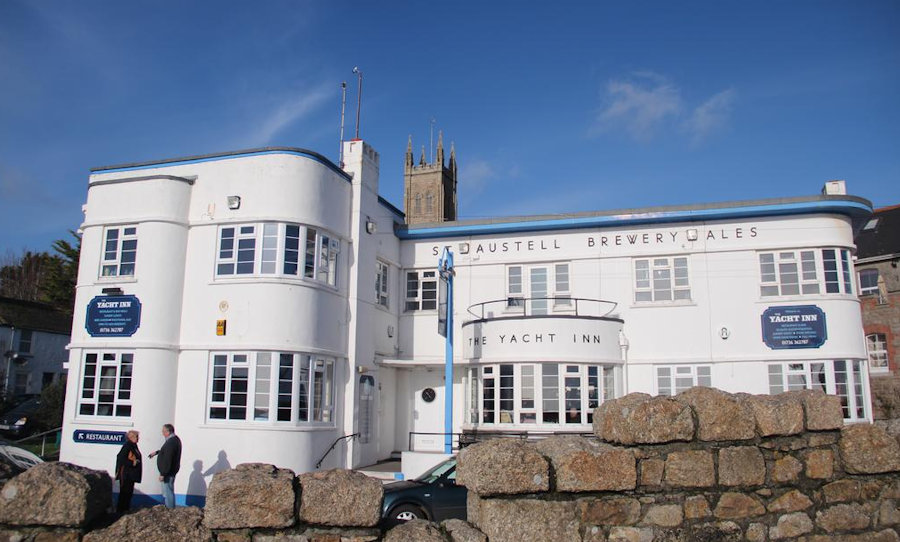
left=216, top=222, right=340, bottom=286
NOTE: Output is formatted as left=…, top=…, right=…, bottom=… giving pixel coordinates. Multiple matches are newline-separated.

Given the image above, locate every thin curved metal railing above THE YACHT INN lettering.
left=468, top=296, right=617, bottom=320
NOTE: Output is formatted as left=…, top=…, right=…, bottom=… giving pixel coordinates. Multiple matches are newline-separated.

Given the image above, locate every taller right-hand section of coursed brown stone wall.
left=458, top=388, right=900, bottom=542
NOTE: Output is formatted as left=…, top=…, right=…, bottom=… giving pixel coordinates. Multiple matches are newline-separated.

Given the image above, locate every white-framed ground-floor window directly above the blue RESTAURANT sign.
left=78, top=352, right=134, bottom=418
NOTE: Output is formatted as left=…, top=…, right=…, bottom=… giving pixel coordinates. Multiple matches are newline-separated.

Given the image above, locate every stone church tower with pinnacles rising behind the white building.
left=403, top=132, right=457, bottom=225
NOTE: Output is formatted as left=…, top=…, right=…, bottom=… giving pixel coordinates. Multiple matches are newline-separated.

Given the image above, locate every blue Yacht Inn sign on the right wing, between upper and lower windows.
left=761, top=305, right=828, bottom=350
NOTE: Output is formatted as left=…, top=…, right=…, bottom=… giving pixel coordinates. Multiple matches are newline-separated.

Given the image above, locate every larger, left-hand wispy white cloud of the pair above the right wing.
left=595, top=72, right=682, bottom=141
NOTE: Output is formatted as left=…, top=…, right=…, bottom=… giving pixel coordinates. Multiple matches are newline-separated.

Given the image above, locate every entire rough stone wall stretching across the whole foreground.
left=0, top=388, right=900, bottom=542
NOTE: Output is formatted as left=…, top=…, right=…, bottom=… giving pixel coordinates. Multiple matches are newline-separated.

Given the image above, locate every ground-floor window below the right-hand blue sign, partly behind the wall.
left=769, top=359, right=868, bottom=421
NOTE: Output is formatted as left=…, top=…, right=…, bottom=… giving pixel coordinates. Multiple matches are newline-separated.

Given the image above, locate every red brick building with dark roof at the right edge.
left=856, top=205, right=900, bottom=418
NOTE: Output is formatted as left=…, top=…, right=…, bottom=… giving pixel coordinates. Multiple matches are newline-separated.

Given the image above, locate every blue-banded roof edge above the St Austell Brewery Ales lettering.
left=397, top=199, right=872, bottom=239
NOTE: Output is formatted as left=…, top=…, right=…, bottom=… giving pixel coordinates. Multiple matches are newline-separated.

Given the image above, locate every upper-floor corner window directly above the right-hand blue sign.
left=759, top=249, right=853, bottom=297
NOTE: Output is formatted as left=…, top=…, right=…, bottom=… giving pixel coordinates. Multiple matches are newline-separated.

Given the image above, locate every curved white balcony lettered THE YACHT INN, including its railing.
left=462, top=297, right=624, bottom=363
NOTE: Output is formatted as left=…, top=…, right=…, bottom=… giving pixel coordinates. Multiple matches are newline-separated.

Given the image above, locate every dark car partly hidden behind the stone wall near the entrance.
left=381, top=457, right=467, bottom=525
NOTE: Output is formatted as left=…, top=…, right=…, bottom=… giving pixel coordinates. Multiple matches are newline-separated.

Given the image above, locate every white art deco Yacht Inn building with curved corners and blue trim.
left=61, top=140, right=871, bottom=503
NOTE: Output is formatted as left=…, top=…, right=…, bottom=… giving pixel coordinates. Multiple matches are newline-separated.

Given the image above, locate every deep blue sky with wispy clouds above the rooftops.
left=0, top=0, right=900, bottom=253
